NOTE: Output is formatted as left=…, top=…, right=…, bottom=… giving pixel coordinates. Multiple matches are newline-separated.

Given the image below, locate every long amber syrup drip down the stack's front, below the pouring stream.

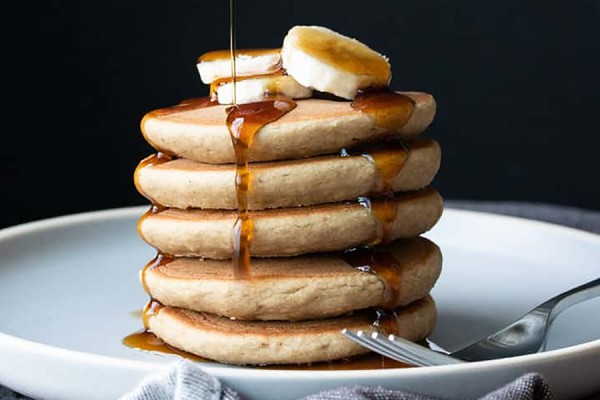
left=227, top=96, right=296, bottom=278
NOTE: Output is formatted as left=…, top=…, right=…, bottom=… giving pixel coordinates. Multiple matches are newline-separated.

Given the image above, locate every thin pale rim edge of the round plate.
left=0, top=205, right=600, bottom=380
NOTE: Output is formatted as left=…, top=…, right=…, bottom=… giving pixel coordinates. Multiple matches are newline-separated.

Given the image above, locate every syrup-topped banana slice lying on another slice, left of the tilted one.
left=196, top=49, right=281, bottom=84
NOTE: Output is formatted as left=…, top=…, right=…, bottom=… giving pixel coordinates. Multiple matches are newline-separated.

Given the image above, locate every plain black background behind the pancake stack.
left=0, top=0, right=600, bottom=227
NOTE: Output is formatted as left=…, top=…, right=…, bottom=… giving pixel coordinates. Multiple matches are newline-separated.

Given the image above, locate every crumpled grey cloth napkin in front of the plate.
left=120, top=360, right=554, bottom=400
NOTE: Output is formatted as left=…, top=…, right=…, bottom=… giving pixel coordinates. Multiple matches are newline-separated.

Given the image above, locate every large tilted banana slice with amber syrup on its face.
left=281, top=26, right=391, bottom=100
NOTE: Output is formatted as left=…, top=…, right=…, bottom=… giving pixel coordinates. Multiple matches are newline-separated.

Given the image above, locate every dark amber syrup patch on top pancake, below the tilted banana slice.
left=351, top=88, right=415, bottom=134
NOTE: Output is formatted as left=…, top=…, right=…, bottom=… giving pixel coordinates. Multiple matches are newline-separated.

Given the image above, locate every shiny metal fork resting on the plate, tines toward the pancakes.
left=342, top=278, right=600, bottom=366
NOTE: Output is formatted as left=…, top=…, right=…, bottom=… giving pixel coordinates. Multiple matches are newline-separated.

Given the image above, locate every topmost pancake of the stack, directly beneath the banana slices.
left=141, top=92, right=435, bottom=164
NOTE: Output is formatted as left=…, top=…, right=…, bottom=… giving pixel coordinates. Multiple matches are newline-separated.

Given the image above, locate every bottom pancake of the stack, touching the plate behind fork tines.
left=148, top=296, right=436, bottom=365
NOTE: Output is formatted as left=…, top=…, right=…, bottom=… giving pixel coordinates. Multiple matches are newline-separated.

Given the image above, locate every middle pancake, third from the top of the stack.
left=138, top=188, right=443, bottom=259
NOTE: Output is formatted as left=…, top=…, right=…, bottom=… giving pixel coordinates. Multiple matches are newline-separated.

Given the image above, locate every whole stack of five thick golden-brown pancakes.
left=135, top=25, right=443, bottom=364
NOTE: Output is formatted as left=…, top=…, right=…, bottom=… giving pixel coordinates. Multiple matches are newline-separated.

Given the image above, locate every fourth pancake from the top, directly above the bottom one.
left=142, top=237, right=442, bottom=320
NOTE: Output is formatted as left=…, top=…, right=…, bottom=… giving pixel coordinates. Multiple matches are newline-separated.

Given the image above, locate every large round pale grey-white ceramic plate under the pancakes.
left=0, top=207, right=600, bottom=400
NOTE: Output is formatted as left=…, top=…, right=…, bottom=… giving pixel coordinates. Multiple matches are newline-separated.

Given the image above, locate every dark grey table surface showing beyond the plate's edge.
left=0, top=200, right=600, bottom=400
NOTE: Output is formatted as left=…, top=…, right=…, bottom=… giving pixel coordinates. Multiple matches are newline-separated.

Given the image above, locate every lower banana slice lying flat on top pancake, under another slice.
left=216, top=74, right=312, bottom=104
